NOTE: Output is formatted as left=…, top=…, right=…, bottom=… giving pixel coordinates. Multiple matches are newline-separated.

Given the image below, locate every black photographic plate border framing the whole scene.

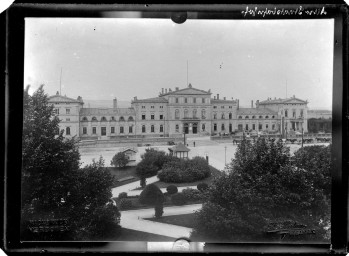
left=1, top=1, right=349, bottom=254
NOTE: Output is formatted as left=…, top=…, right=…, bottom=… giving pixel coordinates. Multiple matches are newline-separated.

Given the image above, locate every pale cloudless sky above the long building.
left=24, top=18, right=334, bottom=109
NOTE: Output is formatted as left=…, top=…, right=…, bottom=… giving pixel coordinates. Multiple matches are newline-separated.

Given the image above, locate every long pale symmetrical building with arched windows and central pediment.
left=49, top=84, right=308, bottom=139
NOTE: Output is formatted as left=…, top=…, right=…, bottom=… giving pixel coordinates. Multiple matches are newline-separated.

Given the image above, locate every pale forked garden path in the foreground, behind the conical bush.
left=120, top=204, right=202, bottom=239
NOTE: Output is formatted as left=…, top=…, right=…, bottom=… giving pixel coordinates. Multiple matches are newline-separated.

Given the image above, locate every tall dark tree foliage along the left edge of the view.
left=21, top=86, right=120, bottom=240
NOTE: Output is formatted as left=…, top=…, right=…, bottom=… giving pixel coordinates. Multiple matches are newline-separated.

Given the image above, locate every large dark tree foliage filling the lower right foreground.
left=192, top=138, right=330, bottom=241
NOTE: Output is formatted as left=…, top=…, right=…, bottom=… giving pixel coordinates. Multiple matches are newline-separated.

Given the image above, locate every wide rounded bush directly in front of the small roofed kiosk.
left=158, top=157, right=211, bottom=183
